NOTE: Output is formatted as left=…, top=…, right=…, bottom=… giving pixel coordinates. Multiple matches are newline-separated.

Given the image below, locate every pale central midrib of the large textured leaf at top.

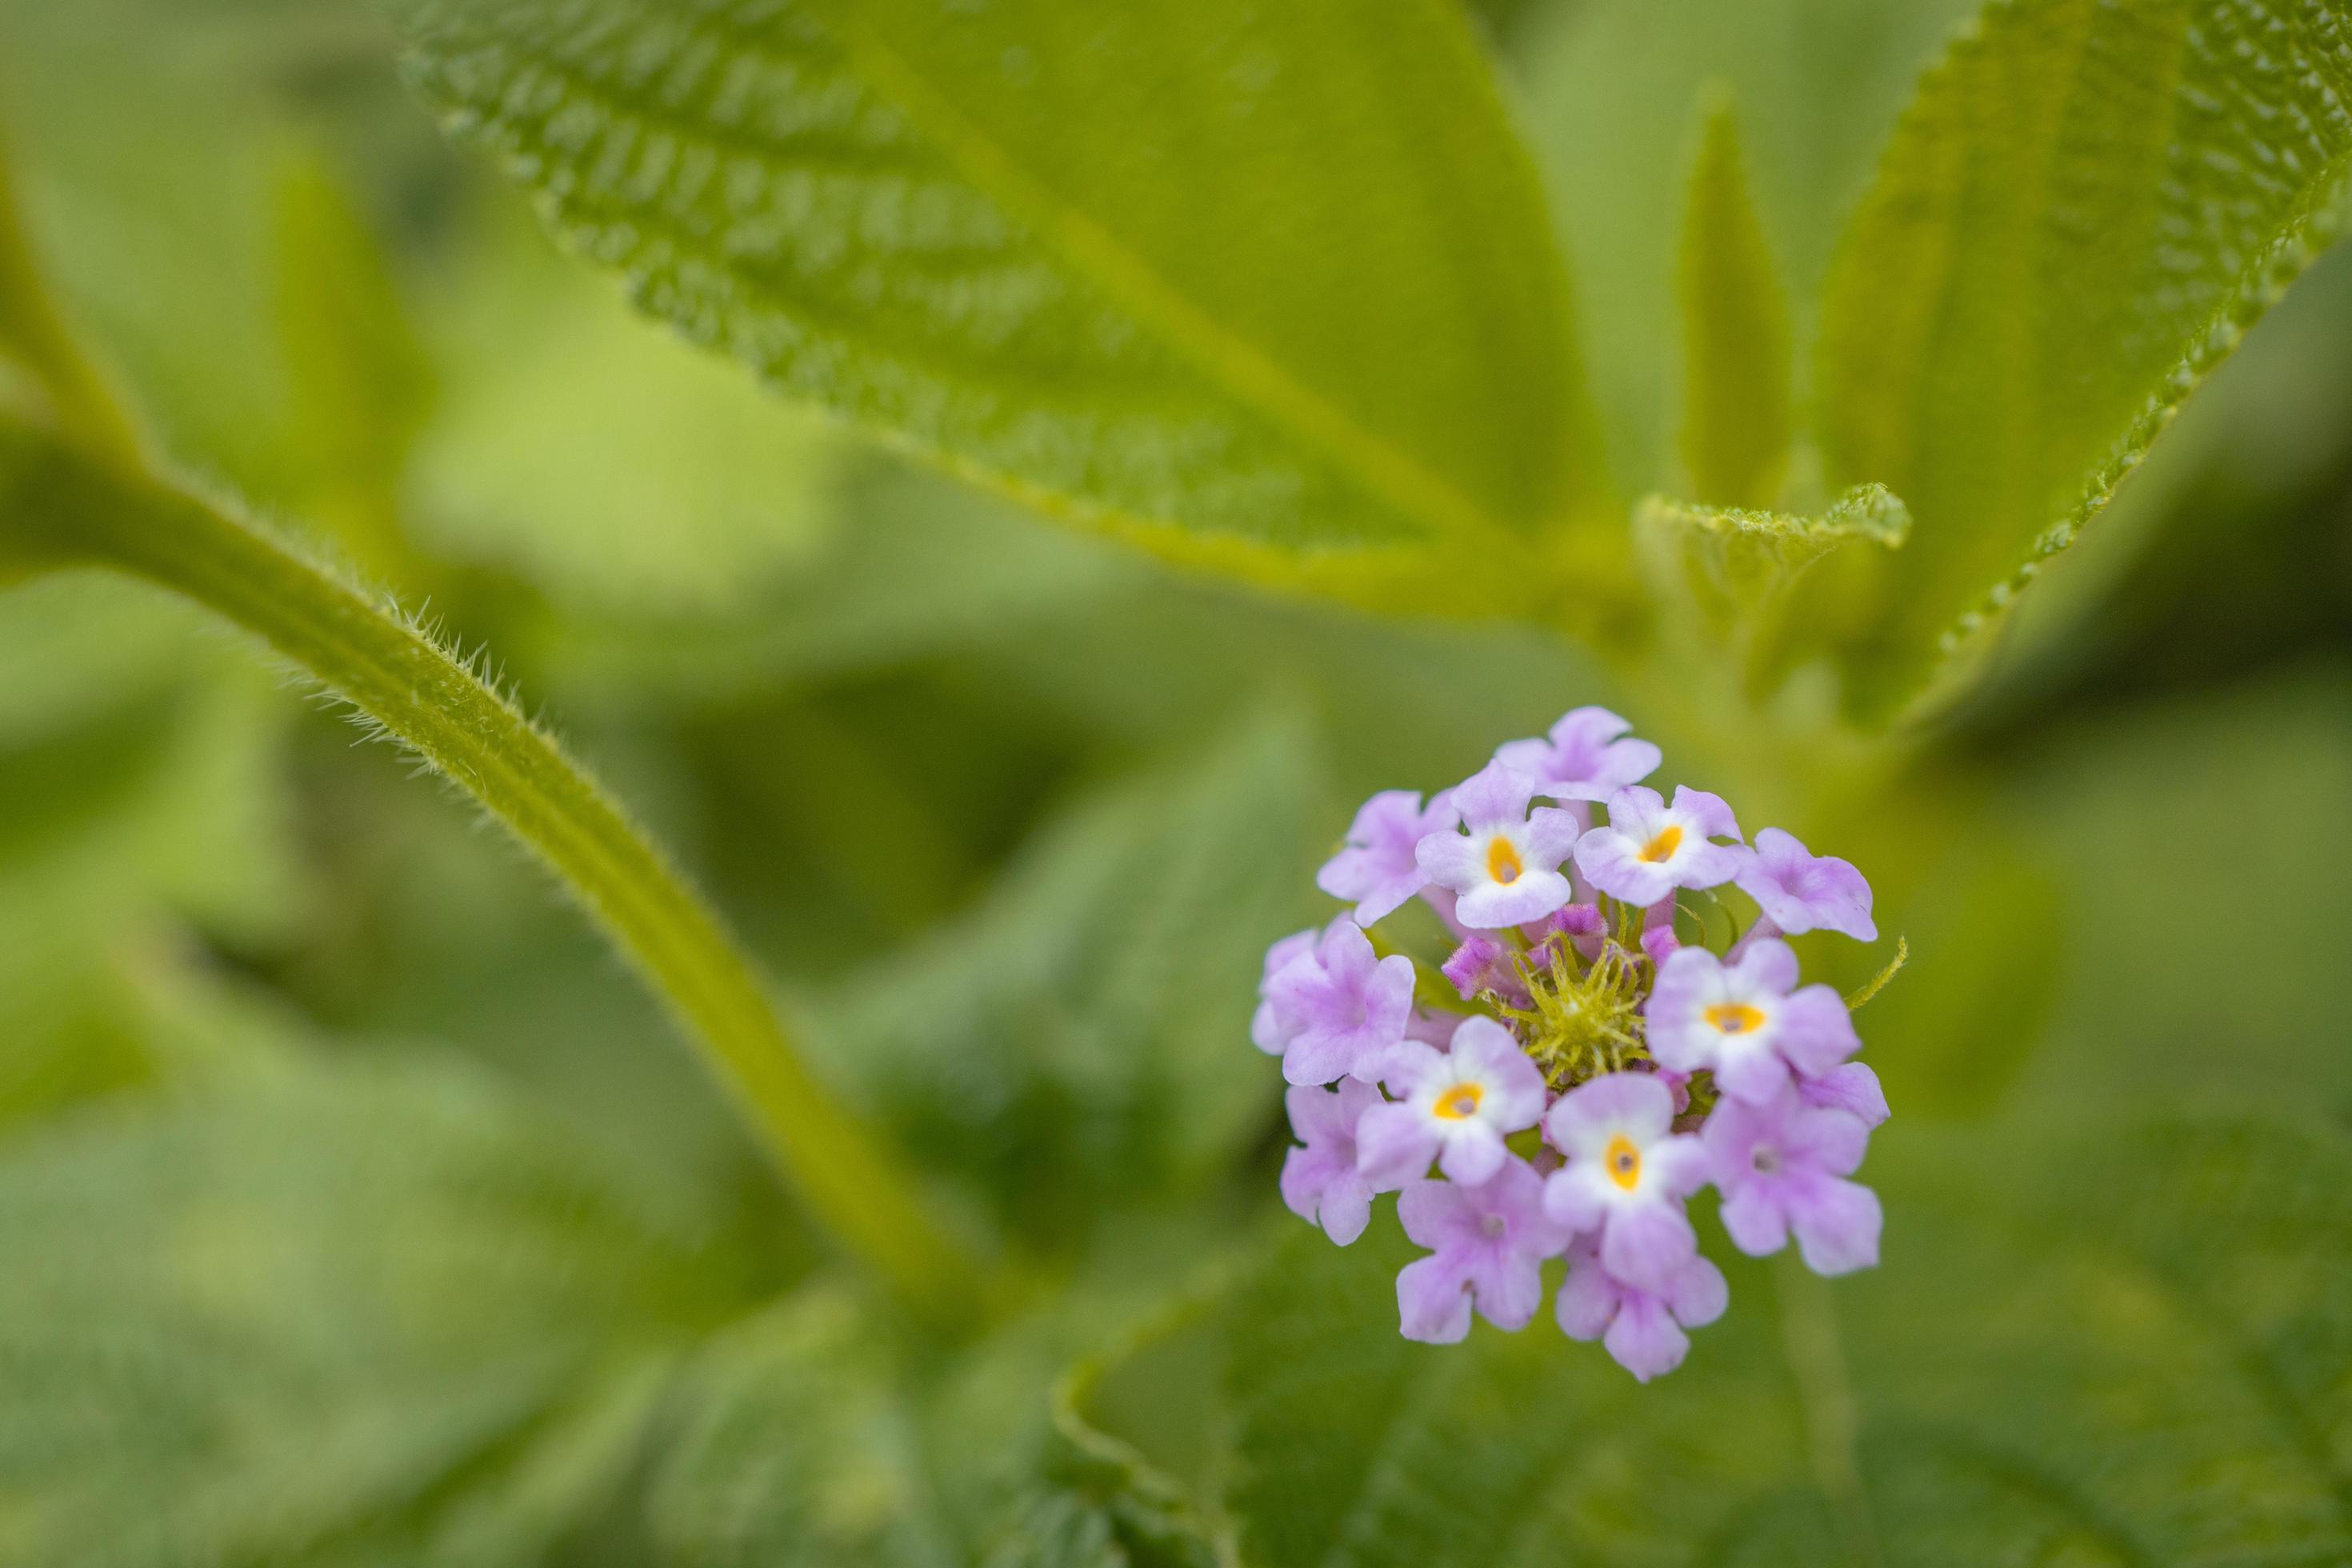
left=823, top=10, right=1514, bottom=554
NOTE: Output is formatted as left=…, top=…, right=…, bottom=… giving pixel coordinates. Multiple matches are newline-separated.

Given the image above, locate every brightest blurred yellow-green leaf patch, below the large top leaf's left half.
left=414, top=192, right=842, bottom=615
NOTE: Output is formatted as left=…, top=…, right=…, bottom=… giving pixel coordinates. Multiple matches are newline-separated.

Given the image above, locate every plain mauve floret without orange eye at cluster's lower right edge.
left=1698, top=1090, right=1879, bottom=1274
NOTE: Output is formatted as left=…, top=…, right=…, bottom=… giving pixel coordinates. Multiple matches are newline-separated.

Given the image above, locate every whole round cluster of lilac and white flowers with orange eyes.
left=1251, top=707, right=1886, bottom=1382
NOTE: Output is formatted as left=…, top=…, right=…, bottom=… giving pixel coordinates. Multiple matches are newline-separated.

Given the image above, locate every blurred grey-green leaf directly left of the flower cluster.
left=818, top=724, right=1317, bottom=1234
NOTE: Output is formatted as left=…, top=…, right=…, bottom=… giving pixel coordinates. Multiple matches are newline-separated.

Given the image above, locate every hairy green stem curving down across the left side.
left=0, top=426, right=986, bottom=1321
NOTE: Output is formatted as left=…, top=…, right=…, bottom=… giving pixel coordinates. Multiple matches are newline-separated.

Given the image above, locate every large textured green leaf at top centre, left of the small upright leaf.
left=390, top=0, right=1592, bottom=562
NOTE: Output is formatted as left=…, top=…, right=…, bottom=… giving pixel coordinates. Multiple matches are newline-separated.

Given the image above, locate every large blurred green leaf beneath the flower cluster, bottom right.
left=1077, top=1119, right=2352, bottom=1568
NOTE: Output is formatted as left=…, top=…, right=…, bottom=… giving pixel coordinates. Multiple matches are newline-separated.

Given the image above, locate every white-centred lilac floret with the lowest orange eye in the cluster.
left=1543, top=1072, right=1707, bottom=1290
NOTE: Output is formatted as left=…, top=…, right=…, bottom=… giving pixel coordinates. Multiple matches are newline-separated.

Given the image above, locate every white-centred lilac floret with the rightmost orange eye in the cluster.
left=1644, top=940, right=1862, bottom=1105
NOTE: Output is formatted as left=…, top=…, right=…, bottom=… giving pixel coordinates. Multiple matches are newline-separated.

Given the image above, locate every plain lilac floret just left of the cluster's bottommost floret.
left=1397, top=1159, right=1569, bottom=1345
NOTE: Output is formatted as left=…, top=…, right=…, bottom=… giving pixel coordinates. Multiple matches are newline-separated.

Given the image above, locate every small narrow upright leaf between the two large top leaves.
left=1679, top=96, right=1794, bottom=506
